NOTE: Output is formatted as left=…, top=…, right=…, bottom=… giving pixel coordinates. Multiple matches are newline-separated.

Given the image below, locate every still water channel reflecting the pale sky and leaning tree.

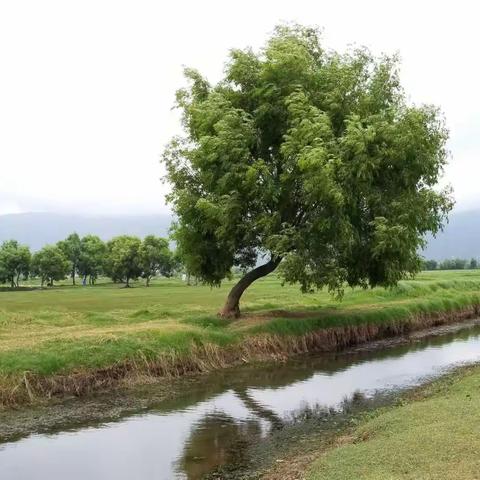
left=0, top=325, right=480, bottom=480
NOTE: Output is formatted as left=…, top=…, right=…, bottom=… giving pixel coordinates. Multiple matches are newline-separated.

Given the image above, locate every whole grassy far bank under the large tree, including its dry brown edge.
left=0, top=271, right=480, bottom=405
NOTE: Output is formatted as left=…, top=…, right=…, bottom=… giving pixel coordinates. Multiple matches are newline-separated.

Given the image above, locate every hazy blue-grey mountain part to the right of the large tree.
left=422, top=210, right=480, bottom=260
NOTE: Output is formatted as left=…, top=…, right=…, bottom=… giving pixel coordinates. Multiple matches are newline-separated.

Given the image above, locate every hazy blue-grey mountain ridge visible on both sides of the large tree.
left=0, top=210, right=480, bottom=260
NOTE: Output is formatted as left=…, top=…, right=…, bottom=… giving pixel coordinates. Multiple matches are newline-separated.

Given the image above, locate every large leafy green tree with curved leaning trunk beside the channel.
left=163, top=26, right=452, bottom=317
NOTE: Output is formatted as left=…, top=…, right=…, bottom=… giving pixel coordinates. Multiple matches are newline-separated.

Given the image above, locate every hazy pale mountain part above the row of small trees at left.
left=0, top=213, right=172, bottom=250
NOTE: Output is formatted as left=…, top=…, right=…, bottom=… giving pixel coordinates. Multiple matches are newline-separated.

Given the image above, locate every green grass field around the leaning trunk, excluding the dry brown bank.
left=0, top=271, right=480, bottom=403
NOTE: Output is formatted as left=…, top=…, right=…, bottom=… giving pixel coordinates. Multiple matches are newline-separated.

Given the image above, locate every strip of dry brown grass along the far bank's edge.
left=0, top=296, right=480, bottom=410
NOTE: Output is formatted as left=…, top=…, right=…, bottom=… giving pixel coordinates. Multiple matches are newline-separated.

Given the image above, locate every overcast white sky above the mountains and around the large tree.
left=0, top=0, right=480, bottom=213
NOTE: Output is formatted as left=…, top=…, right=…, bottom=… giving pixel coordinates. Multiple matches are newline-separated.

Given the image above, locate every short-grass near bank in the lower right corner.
left=306, top=367, right=480, bottom=480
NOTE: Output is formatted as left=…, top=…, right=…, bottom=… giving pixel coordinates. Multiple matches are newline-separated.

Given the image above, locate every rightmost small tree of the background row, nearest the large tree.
left=140, top=235, right=173, bottom=287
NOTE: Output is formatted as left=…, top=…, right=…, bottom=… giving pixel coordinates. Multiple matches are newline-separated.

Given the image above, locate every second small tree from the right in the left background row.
left=106, top=235, right=142, bottom=287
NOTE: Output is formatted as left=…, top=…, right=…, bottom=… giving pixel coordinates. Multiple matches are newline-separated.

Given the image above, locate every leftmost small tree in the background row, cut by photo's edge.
left=0, top=240, right=31, bottom=288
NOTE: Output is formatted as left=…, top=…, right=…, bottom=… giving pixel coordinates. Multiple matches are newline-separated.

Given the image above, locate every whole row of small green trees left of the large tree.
left=0, top=233, right=180, bottom=288
